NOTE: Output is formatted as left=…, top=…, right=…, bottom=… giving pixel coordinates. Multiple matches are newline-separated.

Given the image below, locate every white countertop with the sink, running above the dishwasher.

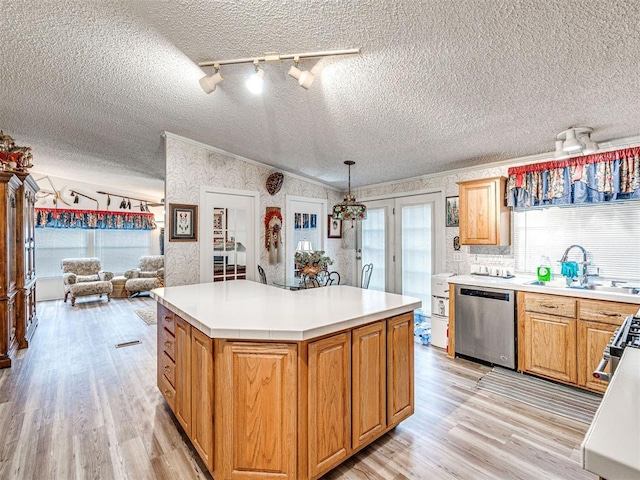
left=447, top=275, right=640, bottom=305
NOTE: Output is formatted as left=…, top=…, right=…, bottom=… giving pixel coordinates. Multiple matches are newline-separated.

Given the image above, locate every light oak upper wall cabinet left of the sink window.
left=458, top=177, right=511, bottom=245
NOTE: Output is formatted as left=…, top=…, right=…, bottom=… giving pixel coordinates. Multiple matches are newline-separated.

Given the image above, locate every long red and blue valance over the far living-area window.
left=36, top=208, right=156, bottom=230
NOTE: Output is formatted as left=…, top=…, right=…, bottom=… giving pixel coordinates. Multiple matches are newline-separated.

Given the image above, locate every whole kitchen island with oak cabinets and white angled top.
left=152, top=281, right=420, bottom=479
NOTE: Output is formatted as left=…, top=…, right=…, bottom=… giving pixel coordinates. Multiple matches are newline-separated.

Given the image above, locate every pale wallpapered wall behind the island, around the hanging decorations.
left=165, top=133, right=355, bottom=286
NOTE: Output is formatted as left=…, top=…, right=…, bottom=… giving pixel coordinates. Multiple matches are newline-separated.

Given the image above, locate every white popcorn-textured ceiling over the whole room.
left=0, top=0, right=640, bottom=197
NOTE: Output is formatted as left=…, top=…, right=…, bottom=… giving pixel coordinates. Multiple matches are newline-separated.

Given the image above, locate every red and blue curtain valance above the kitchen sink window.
left=507, top=147, right=640, bottom=208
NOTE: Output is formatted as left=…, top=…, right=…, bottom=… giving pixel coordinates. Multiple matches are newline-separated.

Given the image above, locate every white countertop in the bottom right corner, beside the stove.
left=581, top=347, right=640, bottom=480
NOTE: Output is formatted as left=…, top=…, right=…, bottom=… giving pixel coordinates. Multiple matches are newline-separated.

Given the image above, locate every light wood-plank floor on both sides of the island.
left=0, top=297, right=597, bottom=480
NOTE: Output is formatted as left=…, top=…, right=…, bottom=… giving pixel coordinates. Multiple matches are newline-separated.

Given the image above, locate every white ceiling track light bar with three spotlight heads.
left=198, top=48, right=360, bottom=93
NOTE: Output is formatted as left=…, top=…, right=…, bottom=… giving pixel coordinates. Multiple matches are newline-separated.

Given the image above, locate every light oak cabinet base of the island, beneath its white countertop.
left=152, top=282, right=419, bottom=480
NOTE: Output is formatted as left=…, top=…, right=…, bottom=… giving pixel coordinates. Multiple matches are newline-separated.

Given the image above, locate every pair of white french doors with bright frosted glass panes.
left=356, top=192, right=445, bottom=314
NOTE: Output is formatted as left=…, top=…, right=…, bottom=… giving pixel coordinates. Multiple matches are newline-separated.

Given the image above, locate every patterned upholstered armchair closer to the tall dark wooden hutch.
left=60, top=258, right=113, bottom=307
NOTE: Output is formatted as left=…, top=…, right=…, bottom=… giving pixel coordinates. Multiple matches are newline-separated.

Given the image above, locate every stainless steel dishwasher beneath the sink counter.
left=454, top=285, right=516, bottom=369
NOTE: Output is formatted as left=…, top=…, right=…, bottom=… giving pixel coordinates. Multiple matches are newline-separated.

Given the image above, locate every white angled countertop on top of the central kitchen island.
left=151, top=280, right=421, bottom=341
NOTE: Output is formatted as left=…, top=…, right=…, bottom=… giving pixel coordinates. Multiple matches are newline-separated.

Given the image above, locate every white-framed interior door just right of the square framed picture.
left=200, top=187, right=258, bottom=282
